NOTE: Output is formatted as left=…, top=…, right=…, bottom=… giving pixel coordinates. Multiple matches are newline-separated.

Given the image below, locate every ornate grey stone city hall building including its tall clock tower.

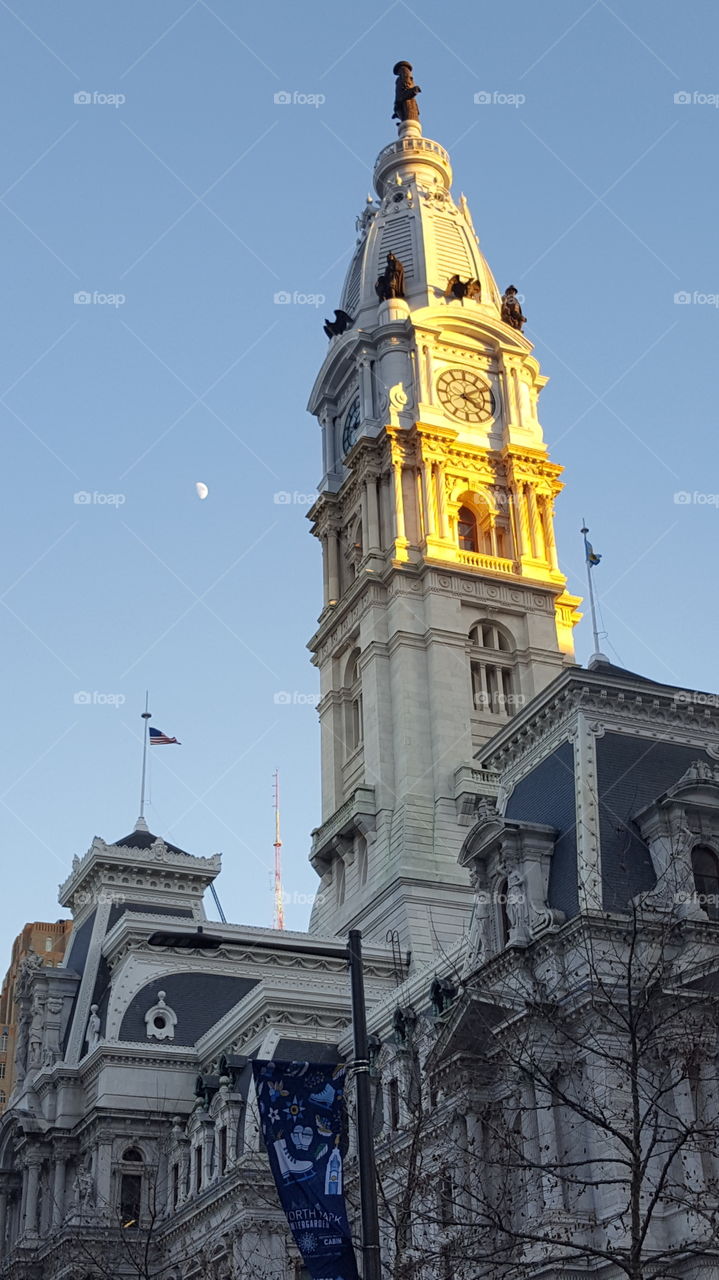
left=0, top=64, right=719, bottom=1280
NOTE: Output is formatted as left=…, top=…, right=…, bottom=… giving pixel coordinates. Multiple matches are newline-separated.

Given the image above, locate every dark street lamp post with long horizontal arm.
left=147, top=925, right=381, bottom=1280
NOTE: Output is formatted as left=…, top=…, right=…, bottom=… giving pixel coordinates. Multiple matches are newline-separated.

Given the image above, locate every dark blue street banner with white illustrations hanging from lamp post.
left=252, top=1061, right=358, bottom=1280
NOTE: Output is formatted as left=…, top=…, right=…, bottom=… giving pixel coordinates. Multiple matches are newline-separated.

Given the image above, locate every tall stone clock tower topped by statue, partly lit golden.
left=308, top=63, right=580, bottom=963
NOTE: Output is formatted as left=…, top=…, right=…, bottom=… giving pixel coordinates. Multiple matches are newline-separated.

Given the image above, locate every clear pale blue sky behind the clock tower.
left=0, top=0, right=719, bottom=950
